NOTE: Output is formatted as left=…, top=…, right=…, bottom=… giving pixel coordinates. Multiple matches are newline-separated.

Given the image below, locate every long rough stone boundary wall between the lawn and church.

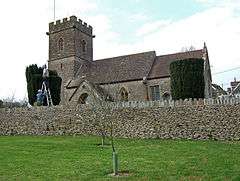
left=0, top=98, right=240, bottom=140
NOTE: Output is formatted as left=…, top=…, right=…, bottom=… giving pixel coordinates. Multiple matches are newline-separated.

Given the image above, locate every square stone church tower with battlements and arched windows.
left=47, top=16, right=93, bottom=102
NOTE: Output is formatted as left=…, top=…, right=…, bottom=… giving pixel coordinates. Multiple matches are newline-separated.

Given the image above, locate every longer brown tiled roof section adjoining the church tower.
left=78, top=51, right=156, bottom=84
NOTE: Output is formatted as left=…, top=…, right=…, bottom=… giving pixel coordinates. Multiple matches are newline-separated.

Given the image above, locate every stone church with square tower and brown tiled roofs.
left=47, top=16, right=212, bottom=105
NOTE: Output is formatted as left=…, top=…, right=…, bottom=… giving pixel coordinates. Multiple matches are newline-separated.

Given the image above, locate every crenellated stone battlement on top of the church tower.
left=49, top=16, right=93, bottom=36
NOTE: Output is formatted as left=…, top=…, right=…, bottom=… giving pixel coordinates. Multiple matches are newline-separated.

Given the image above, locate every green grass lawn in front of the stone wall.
left=0, top=136, right=240, bottom=181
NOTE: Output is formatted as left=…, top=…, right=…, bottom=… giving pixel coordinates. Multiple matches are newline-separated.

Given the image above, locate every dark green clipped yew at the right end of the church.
left=170, top=59, right=205, bottom=100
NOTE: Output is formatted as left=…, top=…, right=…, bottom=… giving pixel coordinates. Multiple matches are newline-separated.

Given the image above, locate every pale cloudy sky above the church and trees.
left=0, top=0, right=240, bottom=99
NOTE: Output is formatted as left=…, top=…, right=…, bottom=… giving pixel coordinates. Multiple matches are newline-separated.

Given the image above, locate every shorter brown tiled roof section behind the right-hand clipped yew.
left=148, top=50, right=203, bottom=79
